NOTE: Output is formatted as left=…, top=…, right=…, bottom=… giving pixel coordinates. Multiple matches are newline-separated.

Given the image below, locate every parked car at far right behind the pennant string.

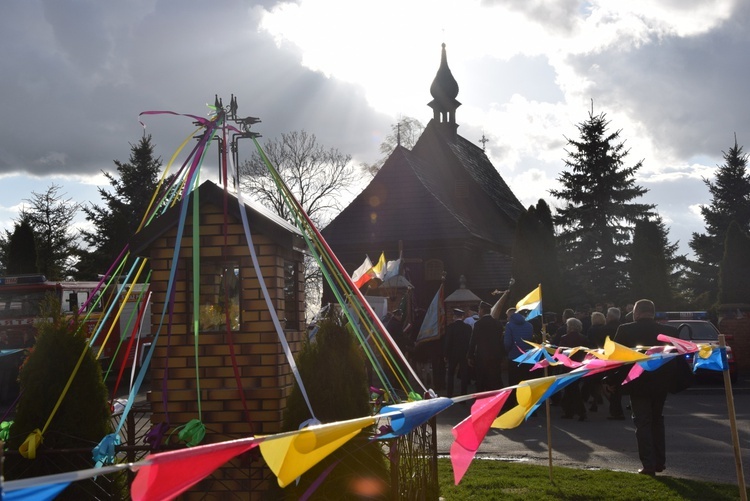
left=656, top=311, right=737, bottom=383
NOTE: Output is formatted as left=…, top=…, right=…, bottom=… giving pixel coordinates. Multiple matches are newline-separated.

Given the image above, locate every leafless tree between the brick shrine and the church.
left=240, top=131, right=357, bottom=311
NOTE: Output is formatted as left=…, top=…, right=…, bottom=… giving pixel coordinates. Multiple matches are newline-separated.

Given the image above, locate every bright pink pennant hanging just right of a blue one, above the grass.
left=451, top=390, right=512, bottom=485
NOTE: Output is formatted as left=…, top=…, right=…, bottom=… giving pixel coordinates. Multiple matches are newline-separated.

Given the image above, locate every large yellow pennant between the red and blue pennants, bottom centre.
left=260, top=416, right=375, bottom=487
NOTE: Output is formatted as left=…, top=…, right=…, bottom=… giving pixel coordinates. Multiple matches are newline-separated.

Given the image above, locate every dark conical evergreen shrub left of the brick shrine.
left=5, top=300, right=112, bottom=493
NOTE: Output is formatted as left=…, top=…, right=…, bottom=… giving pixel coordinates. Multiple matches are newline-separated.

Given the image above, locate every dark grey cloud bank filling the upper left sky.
left=0, top=0, right=390, bottom=175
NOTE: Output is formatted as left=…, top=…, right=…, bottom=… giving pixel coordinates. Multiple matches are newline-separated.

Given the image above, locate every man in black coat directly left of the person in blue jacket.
left=468, top=302, right=505, bottom=391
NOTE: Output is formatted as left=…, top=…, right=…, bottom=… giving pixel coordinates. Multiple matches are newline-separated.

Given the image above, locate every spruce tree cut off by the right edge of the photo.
left=689, top=136, right=750, bottom=307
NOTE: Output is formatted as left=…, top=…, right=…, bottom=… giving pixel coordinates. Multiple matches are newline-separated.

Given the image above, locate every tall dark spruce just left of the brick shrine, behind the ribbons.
left=79, top=135, right=162, bottom=279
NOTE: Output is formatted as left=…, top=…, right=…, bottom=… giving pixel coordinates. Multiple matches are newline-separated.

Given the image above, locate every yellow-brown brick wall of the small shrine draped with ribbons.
left=149, top=205, right=304, bottom=499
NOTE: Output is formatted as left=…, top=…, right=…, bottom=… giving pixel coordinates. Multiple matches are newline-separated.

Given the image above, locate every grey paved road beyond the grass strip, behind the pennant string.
left=437, top=382, right=750, bottom=484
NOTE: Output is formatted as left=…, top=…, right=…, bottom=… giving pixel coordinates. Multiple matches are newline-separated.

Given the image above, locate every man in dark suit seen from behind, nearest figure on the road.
left=614, top=299, right=678, bottom=475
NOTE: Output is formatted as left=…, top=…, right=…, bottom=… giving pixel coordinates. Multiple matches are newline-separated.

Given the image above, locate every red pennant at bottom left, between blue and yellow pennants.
left=130, top=438, right=260, bottom=501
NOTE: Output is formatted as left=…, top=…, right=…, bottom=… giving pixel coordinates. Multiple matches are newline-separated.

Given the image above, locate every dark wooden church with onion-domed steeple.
left=322, top=44, right=525, bottom=309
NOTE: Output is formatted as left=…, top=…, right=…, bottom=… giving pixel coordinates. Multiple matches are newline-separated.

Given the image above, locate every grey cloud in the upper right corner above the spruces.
left=571, top=2, right=750, bottom=158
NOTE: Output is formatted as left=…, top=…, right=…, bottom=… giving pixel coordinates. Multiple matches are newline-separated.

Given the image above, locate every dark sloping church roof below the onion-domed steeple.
left=323, top=117, right=523, bottom=254
